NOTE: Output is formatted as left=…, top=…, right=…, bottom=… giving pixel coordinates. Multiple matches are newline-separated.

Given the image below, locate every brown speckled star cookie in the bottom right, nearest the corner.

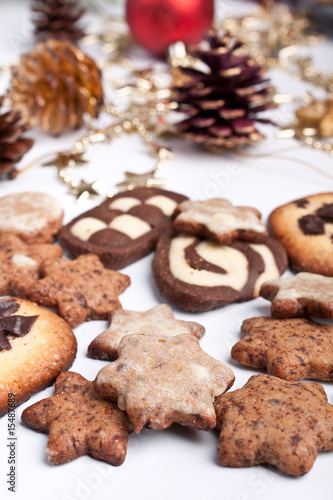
left=215, top=375, right=333, bottom=476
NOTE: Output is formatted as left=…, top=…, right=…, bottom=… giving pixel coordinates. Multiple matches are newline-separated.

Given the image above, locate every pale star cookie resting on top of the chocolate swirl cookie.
left=173, top=198, right=268, bottom=244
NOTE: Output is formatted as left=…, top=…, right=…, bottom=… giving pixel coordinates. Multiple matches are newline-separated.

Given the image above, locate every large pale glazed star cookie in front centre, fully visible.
left=95, top=333, right=234, bottom=432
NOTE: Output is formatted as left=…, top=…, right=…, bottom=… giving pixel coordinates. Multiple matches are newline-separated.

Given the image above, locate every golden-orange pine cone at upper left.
left=8, top=40, right=103, bottom=135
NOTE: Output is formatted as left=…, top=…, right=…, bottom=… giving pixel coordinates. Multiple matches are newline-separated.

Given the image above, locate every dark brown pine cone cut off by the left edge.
left=0, top=97, right=34, bottom=177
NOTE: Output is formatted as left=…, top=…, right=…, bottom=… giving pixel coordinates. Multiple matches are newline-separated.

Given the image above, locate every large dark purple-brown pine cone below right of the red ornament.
left=173, top=30, right=275, bottom=153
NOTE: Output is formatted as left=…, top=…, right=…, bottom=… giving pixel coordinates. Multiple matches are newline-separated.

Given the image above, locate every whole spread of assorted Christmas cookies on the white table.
left=0, top=188, right=333, bottom=476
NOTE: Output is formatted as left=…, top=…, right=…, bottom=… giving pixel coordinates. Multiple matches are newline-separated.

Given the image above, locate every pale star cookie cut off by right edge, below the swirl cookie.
left=260, top=273, right=333, bottom=318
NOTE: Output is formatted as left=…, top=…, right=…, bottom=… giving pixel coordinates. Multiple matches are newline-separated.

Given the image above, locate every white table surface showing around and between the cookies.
left=0, top=0, right=333, bottom=500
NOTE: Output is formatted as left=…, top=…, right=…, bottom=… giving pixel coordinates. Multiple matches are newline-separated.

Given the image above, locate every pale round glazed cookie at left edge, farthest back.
left=0, top=192, right=63, bottom=243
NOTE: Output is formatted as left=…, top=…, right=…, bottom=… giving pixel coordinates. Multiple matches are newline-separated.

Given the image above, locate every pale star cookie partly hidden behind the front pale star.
left=88, top=304, right=205, bottom=361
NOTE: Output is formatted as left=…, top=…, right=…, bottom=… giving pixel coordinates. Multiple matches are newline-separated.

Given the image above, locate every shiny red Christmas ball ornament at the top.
left=126, top=0, right=214, bottom=56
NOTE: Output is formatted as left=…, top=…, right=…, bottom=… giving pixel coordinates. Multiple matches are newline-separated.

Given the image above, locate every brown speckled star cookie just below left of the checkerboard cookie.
left=27, top=254, right=131, bottom=328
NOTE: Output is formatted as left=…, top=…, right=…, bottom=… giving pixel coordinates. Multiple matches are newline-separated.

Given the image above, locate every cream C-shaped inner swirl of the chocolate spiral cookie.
left=169, top=235, right=249, bottom=290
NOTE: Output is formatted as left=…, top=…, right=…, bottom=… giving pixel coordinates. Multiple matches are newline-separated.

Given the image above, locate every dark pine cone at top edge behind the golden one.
left=32, top=0, right=85, bottom=43
